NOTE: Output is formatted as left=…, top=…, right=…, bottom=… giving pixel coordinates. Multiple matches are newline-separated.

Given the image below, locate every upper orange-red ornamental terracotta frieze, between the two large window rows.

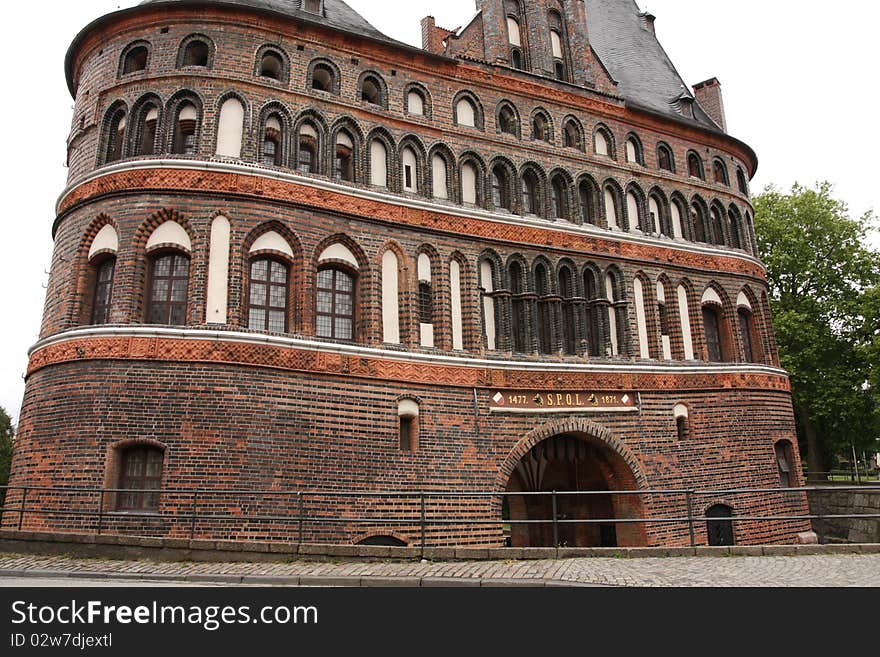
left=56, top=167, right=765, bottom=280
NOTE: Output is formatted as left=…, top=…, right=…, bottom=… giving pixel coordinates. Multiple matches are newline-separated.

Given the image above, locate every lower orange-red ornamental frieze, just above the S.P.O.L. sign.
left=28, top=336, right=790, bottom=393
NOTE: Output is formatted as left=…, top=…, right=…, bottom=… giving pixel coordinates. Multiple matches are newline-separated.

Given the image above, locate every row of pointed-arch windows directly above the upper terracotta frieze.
left=101, top=97, right=754, bottom=252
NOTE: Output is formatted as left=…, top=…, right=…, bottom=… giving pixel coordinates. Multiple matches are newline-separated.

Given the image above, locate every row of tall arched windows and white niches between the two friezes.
left=80, top=218, right=769, bottom=363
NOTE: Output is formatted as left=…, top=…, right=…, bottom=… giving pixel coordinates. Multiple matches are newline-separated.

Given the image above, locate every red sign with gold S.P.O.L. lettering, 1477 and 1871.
left=489, top=390, right=639, bottom=413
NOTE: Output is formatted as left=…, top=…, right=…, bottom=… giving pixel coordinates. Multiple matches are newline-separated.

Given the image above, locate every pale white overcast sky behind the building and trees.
left=0, top=0, right=880, bottom=418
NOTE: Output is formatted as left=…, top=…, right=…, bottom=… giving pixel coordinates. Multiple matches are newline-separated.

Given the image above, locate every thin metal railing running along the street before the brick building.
left=0, top=485, right=880, bottom=549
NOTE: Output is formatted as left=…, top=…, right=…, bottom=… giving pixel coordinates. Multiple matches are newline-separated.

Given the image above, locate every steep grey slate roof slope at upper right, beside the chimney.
left=586, top=0, right=720, bottom=131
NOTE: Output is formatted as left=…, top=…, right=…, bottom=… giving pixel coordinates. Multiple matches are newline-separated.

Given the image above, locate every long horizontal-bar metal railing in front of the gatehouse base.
left=0, top=485, right=880, bottom=550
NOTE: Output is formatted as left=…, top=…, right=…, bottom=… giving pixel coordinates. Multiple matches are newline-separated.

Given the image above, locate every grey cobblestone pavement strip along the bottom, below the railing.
left=0, top=554, right=880, bottom=587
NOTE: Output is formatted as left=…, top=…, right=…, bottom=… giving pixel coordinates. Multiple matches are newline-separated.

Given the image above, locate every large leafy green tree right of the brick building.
left=755, top=182, right=880, bottom=473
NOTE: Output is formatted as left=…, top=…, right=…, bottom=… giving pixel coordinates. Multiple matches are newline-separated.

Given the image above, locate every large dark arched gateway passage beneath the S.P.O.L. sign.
left=502, top=427, right=647, bottom=547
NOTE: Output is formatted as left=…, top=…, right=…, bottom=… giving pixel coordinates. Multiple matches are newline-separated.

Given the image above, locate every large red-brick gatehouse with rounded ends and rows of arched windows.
left=5, top=0, right=808, bottom=546
